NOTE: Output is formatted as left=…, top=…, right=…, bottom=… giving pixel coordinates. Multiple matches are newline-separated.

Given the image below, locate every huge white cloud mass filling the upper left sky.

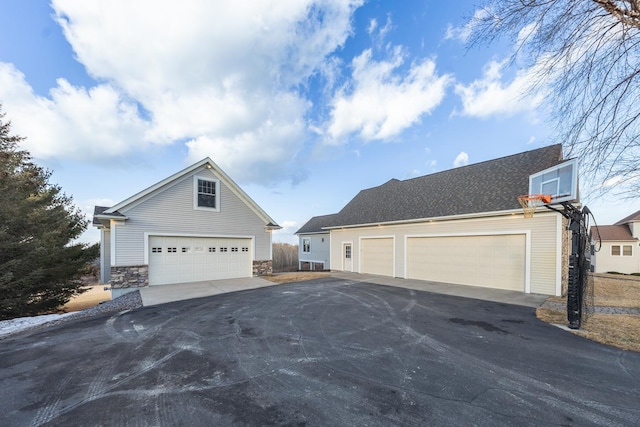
left=0, top=0, right=364, bottom=183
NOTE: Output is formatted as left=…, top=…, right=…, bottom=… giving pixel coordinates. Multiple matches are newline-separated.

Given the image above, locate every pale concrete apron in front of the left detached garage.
left=140, top=277, right=277, bottom=307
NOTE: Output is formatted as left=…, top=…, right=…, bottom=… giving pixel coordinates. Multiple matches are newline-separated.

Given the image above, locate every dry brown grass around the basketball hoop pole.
left=536, top=274, right=640, bottom=352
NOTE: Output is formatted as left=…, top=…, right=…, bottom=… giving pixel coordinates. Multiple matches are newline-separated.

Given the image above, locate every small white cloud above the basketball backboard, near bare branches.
left=455, top=61, right=544, bottom=118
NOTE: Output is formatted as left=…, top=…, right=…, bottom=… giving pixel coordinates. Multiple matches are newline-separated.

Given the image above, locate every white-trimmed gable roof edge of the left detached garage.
left=93, top=157, right=282, bottom=230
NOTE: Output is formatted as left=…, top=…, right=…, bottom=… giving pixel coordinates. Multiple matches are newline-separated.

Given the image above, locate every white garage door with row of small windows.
left=149, top=236, right=253, bottom=285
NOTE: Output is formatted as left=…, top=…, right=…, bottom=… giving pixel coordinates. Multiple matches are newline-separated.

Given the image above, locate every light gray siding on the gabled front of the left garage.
left=115, top=170, right=271, bottom=265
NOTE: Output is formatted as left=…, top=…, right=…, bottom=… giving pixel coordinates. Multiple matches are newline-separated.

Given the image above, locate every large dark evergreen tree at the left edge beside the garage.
left=0, top=105, right=99, bottom=320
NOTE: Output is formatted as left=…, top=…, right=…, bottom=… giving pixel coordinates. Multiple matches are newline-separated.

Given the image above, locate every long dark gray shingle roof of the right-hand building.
left=298, top=144, right=562, bottom=233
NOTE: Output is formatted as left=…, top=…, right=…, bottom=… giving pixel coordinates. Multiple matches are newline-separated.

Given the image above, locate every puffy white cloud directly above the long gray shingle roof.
left=326, top=48, right=451, bottom=144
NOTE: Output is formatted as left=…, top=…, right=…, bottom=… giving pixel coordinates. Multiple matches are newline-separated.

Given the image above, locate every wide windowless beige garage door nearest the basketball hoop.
left=407, top=234, right=526, bottom=291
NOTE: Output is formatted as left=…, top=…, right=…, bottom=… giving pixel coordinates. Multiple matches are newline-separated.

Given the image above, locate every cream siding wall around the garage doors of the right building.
left=331, top=212, right=562, bottom=295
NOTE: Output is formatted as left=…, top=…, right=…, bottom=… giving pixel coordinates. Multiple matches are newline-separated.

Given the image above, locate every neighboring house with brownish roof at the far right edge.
left=591, top=211, right=640, bottom=274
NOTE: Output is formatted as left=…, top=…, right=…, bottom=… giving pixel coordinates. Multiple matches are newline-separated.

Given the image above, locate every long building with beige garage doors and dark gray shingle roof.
left=296, top=144, right=577, bottom=295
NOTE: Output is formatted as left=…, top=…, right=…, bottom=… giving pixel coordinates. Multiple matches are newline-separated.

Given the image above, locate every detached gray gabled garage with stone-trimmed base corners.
left=93, top=158, right=280, bottom=298
